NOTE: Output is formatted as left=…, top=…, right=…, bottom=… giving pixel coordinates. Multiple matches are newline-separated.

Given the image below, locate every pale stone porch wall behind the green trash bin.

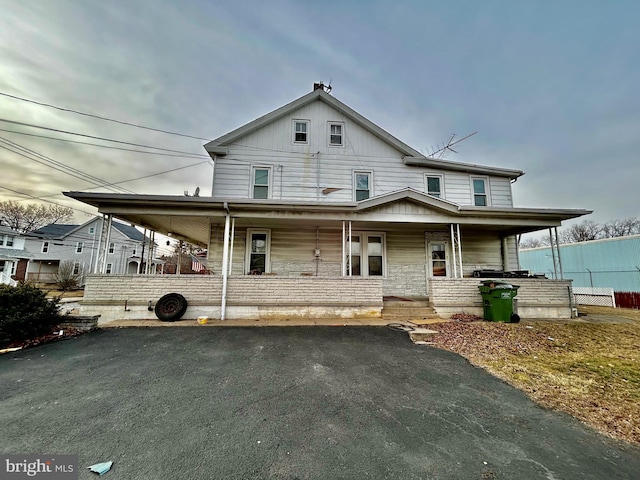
left=429, top=278, right=573, bottom=318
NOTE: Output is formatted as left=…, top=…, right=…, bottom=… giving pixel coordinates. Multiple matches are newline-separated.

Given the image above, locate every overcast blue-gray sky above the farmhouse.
left=0, top=0, right=640, bottom=232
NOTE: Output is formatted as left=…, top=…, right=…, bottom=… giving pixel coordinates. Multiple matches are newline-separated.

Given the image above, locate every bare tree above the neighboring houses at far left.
left=0, top=200, right=73, bottom=233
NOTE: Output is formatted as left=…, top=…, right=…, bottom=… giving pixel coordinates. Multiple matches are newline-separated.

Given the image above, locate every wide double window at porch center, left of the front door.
left=345, top=234, right=385, bottom=277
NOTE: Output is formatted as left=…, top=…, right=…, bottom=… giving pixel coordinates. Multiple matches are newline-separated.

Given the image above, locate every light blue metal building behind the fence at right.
left=520, top=235, right=640, bottom=292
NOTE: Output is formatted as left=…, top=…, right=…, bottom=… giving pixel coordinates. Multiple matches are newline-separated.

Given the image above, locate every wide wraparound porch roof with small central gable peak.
left=64, top=188, right=591, bottom=246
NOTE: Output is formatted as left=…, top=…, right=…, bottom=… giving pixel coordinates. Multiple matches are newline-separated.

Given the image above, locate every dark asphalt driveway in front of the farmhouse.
left=0, top=327, right=640, bottom=480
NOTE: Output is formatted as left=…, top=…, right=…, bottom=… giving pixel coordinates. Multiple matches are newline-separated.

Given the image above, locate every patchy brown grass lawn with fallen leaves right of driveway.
left=424, top=307, right=640, bottom=444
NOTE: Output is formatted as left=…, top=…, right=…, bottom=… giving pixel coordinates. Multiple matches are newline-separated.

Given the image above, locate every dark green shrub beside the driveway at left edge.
left=0, top=283, right=62, bottom=347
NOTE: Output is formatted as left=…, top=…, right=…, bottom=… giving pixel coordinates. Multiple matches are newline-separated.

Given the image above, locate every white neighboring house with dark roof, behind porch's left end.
left=24, top=218, right=162, bottom=284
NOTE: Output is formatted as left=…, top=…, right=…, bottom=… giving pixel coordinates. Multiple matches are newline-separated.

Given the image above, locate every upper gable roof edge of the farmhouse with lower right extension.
left=204, top=88, right=524, bottom=178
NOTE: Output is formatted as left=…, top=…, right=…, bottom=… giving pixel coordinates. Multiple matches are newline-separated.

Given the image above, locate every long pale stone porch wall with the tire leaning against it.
left=80, top=275, right=382, bottom=323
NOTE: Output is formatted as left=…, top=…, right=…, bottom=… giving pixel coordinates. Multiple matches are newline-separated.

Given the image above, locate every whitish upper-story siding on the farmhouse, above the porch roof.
left=213, top=101, right=512, bottom=206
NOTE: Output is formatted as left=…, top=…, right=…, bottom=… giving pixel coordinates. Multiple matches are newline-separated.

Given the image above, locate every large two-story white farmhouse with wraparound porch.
left=66, top=85, right=589, bottom=318
